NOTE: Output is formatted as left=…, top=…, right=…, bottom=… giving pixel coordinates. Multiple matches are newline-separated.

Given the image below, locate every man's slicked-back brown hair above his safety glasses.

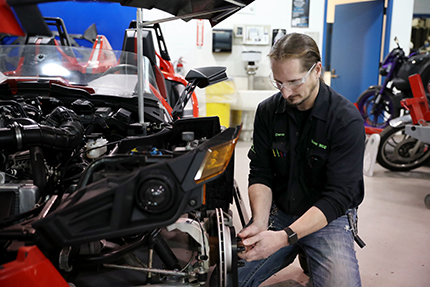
left=268, top=33, right=323, bottom=78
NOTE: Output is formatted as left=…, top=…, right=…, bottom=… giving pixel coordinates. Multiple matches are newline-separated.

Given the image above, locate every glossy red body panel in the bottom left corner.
left=0, top=246, right=69, bottom=287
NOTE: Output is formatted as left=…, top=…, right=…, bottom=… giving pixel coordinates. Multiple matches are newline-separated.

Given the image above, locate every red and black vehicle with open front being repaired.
left=0, top=0, right=252, bottom=286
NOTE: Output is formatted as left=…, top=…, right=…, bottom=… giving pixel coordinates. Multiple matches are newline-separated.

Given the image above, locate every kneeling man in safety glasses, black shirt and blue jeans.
left=238, top=33, right=365, bottom=287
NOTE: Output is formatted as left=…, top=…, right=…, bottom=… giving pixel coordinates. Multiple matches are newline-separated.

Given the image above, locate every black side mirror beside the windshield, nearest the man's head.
left=185, top=67, right=228, bottom=89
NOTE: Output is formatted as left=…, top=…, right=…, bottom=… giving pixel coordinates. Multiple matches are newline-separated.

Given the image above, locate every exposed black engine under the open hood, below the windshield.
left=0, top=93, right=163, bottom=217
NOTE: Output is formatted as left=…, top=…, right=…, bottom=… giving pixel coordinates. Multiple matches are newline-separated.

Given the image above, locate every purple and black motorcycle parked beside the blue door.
left=357, top=37, right=430, bottom=128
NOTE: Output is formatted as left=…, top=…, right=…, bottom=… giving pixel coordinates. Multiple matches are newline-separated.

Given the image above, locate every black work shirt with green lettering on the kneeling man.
left=248, top=83, right=365, bottom=223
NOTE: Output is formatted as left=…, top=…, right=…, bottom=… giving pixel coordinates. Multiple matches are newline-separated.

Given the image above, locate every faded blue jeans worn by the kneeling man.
left=238, top=207, right=361, bottom=287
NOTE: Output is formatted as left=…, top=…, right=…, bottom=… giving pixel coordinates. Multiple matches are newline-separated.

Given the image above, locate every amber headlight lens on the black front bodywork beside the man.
left=194, top=135, right=239, bottom=183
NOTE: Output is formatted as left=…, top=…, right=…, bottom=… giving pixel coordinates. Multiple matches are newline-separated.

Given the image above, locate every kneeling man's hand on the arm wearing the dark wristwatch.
left=238, top=230, right=288, bottom=262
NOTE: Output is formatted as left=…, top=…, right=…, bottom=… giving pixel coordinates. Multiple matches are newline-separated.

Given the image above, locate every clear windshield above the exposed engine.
left=0, top=45, right=158, bottom=97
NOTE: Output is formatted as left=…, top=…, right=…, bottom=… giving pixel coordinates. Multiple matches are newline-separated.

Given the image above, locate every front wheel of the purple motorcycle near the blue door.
left=357, top=86, right=400, bottom=128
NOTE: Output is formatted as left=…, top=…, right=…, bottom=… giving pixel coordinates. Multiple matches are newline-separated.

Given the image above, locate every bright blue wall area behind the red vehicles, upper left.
left=38, top=2, right=136, bottom=50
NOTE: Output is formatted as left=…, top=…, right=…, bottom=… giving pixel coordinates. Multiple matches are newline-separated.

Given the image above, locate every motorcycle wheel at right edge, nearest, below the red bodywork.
left=376, top=125, right=430, bottom=171
